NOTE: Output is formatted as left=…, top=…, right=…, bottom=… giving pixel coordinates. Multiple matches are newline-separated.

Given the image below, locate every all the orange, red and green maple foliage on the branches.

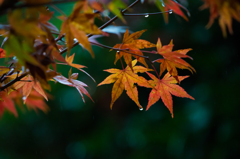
left=0, top=0, right=240, bottom=117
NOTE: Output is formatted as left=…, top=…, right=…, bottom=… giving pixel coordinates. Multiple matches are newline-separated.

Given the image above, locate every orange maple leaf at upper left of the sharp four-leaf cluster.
left=113, top=29, right=156, bottom=68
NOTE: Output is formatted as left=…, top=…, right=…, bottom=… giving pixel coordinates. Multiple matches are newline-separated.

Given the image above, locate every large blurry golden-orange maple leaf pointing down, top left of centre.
left=60, top=1, right=102, bottom=57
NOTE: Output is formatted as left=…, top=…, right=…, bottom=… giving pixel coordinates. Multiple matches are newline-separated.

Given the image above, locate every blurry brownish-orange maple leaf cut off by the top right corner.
left=200, top=0, right=240, bottom=37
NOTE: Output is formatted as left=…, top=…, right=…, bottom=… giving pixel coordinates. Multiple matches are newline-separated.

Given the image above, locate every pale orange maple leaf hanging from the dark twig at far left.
left=13, top=75, right=48, bottom=103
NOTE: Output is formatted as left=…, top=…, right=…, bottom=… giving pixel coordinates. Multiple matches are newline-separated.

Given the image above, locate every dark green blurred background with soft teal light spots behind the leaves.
left=0, top=0, right=240, bottom=159
